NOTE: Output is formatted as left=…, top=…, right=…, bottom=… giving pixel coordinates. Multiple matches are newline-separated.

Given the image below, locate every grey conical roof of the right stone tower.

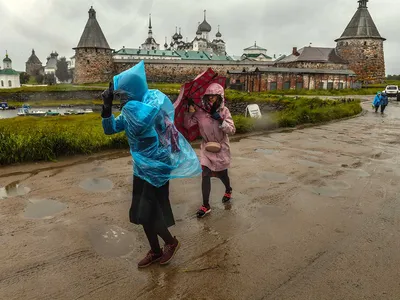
left=335, top=0, right=386, bottom=42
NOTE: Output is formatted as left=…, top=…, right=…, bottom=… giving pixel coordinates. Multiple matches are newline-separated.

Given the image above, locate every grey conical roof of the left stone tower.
left=74, top=6, right=111, bottom=49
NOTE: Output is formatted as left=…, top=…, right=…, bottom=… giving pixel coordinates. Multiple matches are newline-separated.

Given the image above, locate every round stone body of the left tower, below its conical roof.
left=73, top=48, right=113, bottom=84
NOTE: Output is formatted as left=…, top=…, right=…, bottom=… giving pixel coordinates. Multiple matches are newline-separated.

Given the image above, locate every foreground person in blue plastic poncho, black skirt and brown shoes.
left=101, top=61, right=201, bottom=268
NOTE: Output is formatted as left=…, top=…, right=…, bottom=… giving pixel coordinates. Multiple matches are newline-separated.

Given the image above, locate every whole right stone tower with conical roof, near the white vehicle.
left=335, top=0, right=386, bottom=83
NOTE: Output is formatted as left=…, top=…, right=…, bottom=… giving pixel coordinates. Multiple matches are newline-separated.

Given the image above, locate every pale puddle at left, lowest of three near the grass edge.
left=24, top=199, right=67, bottom=219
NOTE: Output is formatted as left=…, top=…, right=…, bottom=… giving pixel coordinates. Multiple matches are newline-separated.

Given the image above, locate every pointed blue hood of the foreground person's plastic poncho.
left=113, top=60, right=149, bottom=101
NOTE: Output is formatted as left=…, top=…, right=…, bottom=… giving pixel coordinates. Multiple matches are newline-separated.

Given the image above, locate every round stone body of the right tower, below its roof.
left=336, top=39, right=385, bottom=83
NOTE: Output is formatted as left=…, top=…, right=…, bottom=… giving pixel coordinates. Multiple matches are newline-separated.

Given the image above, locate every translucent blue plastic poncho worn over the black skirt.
left=102, top=61, right=201, bottom=187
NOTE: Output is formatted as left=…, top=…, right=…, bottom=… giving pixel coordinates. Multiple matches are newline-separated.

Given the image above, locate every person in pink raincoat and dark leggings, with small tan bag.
left=185, top=83, right=236, bottom=218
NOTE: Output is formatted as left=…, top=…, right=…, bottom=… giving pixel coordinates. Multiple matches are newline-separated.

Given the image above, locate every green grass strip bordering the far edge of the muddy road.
left=0, top=98, right=362, bottom=165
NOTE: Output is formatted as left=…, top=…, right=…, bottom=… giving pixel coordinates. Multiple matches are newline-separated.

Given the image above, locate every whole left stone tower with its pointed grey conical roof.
left=73, top=7, right=113, bottom=84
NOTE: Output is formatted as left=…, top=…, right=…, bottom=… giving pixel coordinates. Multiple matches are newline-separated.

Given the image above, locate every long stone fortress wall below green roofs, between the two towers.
left=114, top=60, right=272, bottom=83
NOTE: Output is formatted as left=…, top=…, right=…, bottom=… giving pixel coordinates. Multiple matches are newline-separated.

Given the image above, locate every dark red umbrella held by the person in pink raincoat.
left=174, top=68, right=226, bottom=141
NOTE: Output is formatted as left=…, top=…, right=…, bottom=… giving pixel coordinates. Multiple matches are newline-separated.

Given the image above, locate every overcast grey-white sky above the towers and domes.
left=0, top=0, right=400, bottom=74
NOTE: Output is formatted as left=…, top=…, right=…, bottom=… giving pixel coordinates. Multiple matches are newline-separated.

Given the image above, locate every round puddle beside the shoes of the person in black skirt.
left=89, top=225, right=136, bottom=257
